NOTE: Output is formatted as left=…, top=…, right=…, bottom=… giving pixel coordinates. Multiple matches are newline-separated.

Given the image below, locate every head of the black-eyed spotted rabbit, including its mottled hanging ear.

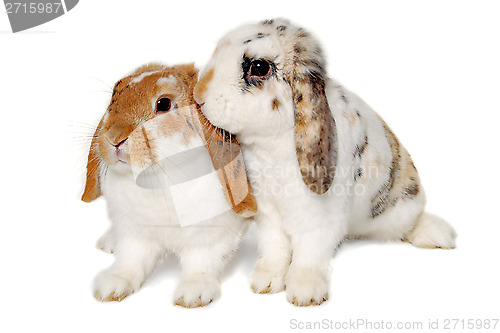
left=194, top=19, right=337, bottom=194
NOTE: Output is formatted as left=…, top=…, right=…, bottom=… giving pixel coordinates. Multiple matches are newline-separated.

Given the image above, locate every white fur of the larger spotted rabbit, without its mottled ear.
left=195, top=21, right=454, bottom=305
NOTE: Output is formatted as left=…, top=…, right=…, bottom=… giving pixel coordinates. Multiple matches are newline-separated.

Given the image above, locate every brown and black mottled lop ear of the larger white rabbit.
left=284, top=29, right=337, bottom=194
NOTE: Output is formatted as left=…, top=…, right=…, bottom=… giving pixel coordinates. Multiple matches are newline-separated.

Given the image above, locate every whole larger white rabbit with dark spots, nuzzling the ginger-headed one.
left=195, top=19, right=456, bottom=306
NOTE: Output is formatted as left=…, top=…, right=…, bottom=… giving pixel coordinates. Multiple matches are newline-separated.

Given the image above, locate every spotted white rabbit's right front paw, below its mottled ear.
left=286, top=267, right=328, bottom=306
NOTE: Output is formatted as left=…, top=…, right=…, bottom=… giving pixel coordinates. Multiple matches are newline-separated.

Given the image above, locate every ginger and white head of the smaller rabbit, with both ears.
left=82, top=64, right=257, bottom=217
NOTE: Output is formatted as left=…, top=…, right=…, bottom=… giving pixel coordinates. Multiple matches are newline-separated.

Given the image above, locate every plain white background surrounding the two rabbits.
left=0, top=0, right=500, bottom=332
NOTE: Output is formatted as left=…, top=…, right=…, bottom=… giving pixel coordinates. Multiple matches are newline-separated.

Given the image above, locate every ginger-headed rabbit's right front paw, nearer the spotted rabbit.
left=175, top=274, right=220, bottom=308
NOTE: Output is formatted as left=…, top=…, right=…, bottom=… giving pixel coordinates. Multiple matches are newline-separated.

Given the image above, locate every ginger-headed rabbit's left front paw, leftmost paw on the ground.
left=94, top=268, right=140, bottom=302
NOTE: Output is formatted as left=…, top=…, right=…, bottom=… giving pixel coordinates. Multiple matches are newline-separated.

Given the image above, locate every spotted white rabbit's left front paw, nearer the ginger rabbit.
left=252, top=263, right=287, bottom=294
